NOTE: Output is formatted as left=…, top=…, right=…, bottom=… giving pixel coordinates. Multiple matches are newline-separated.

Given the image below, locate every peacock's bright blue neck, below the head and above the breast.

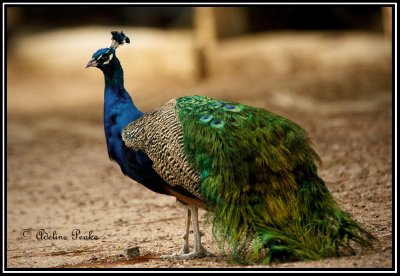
left=100, top=57, right=143, bottom=166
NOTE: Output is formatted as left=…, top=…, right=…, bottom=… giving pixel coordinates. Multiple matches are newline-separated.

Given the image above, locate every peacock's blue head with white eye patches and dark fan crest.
left=86, top=31, right=130, bottom=70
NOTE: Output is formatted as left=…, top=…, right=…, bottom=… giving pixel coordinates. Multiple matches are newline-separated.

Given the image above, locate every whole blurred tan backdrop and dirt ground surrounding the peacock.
left=5, top=5, right=393, bottom=267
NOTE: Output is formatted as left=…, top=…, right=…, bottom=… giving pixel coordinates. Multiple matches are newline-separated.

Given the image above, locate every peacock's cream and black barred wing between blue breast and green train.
left=122, top=100, right=202, bottom=203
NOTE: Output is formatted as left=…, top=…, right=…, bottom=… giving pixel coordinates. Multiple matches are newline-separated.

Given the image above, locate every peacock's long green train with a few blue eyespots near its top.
left=176, top=96, right=372, bottom=263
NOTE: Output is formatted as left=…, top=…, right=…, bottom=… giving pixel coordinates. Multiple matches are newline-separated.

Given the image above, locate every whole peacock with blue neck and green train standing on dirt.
left=86, top=32, right=372, bottom=263
